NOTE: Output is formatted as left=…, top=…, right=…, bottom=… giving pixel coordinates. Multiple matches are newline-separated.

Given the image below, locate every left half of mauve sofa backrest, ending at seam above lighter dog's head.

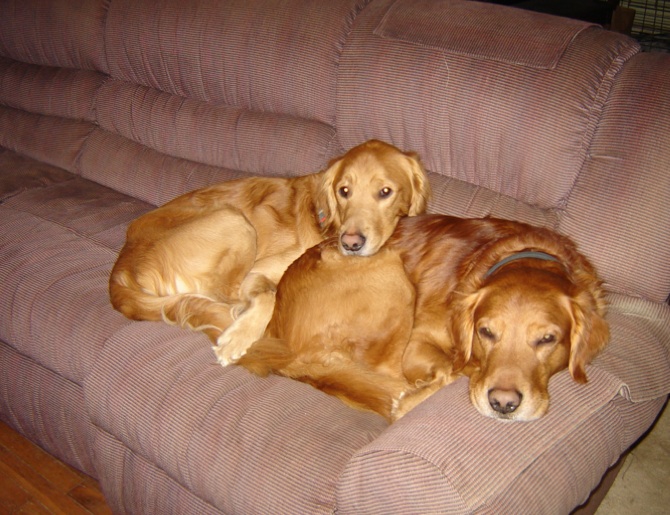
left=0, top=0, right=366, bottom=205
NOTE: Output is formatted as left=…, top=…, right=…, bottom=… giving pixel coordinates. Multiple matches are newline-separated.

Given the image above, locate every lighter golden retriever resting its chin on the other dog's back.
left=109, top=140, right=430, bottom=365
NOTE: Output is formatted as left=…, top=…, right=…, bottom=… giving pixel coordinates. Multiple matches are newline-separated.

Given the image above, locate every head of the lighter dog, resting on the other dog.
left=322, top=140, right=430, bottom=256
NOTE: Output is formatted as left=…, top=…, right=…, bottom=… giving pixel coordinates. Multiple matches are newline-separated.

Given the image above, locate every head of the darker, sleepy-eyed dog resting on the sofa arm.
left=451, top=232, right=609, bottom=420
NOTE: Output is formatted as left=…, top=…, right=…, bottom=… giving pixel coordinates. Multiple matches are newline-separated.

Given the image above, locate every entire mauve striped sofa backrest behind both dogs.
left=0, top=0, right=670, bottom=301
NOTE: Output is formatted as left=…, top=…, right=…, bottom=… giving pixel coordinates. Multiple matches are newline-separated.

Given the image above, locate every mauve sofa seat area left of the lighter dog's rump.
left=0, top=176, right=150, bottom=384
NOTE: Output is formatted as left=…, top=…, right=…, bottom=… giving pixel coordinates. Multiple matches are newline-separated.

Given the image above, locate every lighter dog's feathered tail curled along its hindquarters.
left=109, top=275, right=233, bottom=342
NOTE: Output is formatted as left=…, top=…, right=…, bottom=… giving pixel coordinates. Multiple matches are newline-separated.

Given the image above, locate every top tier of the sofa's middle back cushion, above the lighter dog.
left=105, top=0, right=365, bottom=124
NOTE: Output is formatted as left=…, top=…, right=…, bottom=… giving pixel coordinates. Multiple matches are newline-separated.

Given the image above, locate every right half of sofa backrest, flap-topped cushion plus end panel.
left=337, top=0, right=670, bottom=301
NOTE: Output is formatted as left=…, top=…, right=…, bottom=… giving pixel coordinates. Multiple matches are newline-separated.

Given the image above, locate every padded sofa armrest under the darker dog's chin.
left=337, top=371, right=665, bottom=515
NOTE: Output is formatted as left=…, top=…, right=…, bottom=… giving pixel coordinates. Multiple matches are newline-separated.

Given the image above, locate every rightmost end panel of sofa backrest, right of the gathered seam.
left=558, top=52, right=670, bottom=302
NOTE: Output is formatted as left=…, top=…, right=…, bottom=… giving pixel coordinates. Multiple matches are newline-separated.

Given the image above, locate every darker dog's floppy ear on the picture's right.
left=569, top=291, right=609, bottom=383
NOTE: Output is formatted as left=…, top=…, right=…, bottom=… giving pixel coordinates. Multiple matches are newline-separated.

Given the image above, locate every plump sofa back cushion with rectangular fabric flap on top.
left=338, top=0, right=639, bottom=209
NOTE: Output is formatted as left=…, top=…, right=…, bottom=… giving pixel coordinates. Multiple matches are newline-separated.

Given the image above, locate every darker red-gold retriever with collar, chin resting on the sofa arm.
left=239, top=215, right=609, bottom=421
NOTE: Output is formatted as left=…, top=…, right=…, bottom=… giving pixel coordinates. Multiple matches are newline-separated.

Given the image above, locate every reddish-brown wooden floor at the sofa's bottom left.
left=0, top=422, right=111, bottom=515
